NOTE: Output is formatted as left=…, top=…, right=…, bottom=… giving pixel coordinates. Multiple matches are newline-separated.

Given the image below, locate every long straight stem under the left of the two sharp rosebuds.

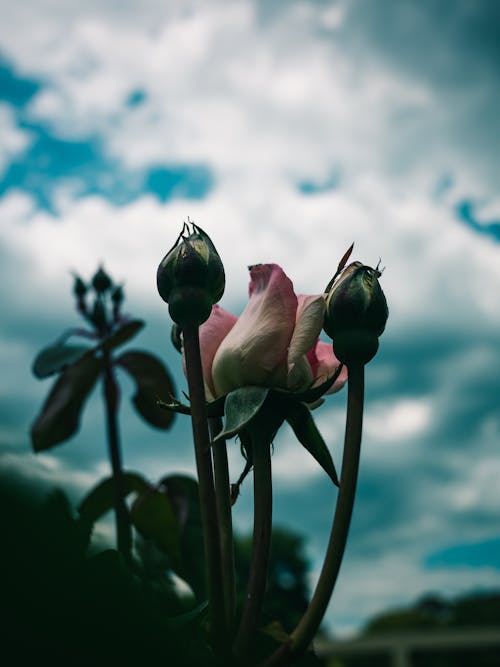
left=182, top=324, right=225, bottom=649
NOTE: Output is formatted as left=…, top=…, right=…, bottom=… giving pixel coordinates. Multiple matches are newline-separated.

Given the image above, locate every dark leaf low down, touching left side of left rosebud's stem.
left=160, top=475, right=207, bottom=600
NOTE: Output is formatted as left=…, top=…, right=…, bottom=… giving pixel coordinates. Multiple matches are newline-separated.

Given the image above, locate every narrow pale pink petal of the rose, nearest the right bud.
left=287, top=294, right=326, bottom=390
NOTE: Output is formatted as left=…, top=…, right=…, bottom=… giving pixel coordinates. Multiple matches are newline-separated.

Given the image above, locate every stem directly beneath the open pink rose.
left=234, top=429, right=273, bottom=662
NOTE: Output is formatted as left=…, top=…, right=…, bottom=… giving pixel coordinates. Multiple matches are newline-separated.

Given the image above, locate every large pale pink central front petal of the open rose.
left=212, top=264, right=297, bottom=395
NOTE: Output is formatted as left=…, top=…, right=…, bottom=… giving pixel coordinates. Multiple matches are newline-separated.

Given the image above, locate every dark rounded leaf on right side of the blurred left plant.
left=116, top=350, right=174, bottom=429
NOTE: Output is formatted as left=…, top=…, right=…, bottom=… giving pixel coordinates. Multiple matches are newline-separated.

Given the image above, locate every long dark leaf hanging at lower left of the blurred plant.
left=31, top=355, right=102, bottom=452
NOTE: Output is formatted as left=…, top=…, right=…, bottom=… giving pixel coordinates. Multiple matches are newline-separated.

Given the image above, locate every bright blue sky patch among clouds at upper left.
left=0, top=56, right=214, bottom=215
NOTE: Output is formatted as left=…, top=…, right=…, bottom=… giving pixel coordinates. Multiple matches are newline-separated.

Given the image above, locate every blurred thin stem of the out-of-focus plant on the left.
left=103, top=354, right=132, bottom=563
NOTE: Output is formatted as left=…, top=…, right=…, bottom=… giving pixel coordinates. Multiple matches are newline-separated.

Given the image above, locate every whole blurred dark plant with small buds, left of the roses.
left=31, top=267, right=174, bottom=559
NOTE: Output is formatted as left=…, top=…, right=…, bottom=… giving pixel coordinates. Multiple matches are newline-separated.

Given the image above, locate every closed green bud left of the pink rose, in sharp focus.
left=156, top=224, right=225, bottom=326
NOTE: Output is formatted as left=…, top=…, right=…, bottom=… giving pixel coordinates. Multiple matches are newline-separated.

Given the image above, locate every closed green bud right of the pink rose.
left=323, top=262, right=389, bottom=365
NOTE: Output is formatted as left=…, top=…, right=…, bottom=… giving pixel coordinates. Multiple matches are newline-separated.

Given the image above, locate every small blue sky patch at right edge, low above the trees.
left=424, top=537, right=500, bottom=569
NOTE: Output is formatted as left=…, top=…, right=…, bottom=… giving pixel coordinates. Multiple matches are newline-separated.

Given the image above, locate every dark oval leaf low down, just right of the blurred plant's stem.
left=131, top=489, right=181, bottom=568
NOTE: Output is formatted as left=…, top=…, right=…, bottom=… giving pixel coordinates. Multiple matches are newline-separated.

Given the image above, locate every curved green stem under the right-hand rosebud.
left=262, top=363, right=364, bottom=667
